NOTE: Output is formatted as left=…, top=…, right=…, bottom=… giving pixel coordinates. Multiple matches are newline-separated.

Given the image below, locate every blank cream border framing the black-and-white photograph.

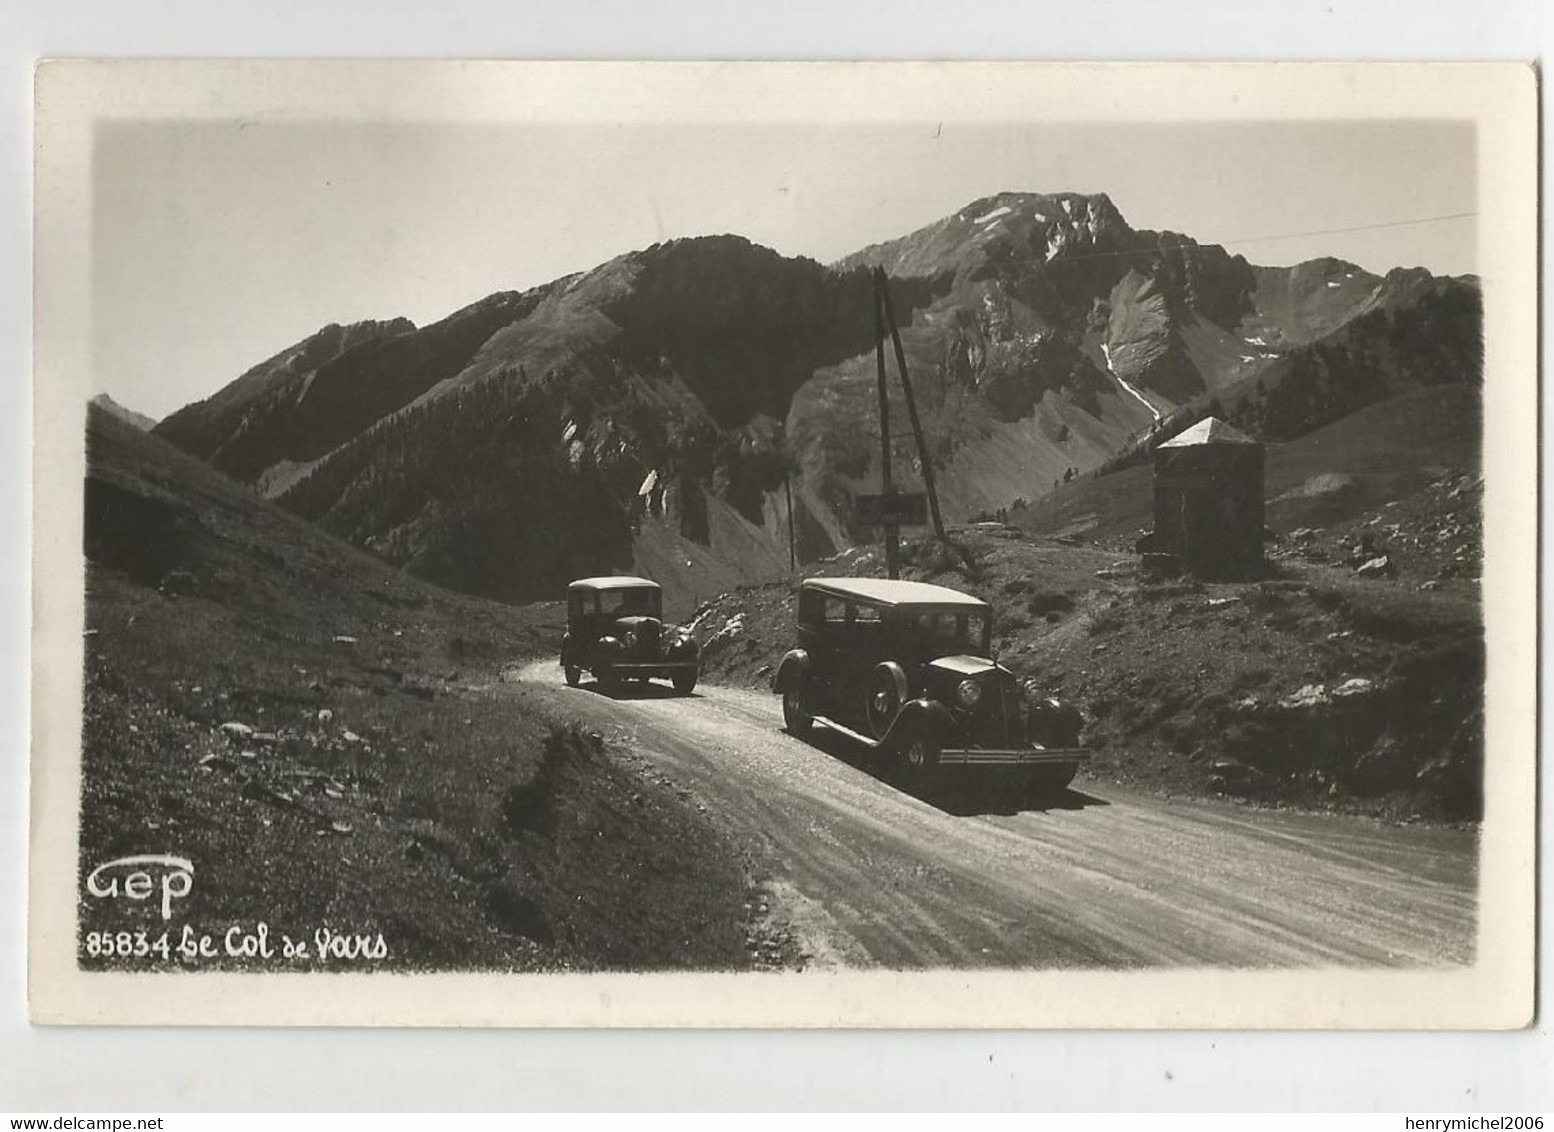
left=30, top=62, right=1538, bottom=1029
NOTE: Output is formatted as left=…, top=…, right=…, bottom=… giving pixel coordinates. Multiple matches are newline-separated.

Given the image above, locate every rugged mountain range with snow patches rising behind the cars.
left=148, top=193, right=1483, bottom=600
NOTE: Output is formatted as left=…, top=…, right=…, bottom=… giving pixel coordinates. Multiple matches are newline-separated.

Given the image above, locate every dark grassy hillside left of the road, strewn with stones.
left=81, top=411, right=747, bottom=970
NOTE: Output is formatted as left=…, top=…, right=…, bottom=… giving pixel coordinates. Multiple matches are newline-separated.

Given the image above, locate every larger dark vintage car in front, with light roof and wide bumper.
left=772, top=578, right=1089, bottom=791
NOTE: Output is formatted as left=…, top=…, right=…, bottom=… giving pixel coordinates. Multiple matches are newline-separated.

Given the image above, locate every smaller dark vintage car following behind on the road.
left=561, top=577, right=701, bottom=695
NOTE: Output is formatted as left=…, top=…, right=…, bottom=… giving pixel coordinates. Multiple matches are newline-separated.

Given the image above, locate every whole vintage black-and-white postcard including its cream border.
left=28, top=61, right=1537, bottom=1028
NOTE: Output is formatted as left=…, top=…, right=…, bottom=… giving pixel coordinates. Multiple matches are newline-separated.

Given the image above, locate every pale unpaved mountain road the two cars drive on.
left=503, top=661, right=1478, bottom=969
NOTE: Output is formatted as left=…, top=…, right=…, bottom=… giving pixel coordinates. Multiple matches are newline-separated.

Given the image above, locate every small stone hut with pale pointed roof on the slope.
left=1145, top=417, right=1265, bottom=577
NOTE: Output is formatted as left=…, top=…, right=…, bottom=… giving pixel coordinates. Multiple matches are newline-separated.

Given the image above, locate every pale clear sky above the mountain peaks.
left=90, top=120, right=1478, bottom=418
